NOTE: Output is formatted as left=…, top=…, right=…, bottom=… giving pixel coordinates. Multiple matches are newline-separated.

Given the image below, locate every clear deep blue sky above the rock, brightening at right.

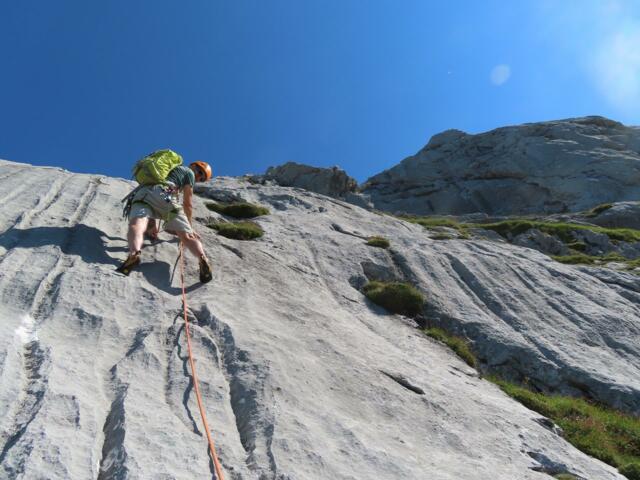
left=0, top=0, right=640, bottom=181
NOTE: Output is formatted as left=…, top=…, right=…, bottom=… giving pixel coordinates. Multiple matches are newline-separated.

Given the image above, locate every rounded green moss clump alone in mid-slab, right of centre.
left=362, top=281, right=424, bottom=317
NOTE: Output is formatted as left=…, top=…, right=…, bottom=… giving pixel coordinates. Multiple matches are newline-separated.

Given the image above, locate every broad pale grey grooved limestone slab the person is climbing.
left=0, top=161, right=640, bottom=480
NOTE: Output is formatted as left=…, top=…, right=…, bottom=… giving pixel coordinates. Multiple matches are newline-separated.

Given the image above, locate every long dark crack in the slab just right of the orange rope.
left=202, top=308, right=278, bottom=480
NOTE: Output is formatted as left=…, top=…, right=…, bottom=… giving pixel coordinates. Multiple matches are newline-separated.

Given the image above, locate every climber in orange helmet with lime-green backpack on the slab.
left=118, top=150, right=212, bottom=283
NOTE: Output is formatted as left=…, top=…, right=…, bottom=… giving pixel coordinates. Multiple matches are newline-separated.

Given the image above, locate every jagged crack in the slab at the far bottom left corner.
left=0, top=340, right=50, bottom=478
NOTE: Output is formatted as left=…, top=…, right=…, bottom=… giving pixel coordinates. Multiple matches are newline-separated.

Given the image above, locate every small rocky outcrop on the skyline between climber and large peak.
left=264, top=162, right=358, bottom=197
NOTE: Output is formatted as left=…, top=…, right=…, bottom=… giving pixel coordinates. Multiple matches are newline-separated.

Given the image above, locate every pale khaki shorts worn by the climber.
left=129, top=185, right=193, bottom=233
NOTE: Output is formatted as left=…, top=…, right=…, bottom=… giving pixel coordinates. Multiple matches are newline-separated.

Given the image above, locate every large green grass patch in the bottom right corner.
left=492, top=378, right=640, bottom=480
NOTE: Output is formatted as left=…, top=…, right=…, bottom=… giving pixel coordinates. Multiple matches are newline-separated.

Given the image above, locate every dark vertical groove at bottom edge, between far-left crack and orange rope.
left=98, top=378, right=128, bottom=480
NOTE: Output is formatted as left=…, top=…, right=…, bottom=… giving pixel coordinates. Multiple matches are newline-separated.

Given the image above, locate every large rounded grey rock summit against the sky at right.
left=362, top=117, right=640, bottom=215
